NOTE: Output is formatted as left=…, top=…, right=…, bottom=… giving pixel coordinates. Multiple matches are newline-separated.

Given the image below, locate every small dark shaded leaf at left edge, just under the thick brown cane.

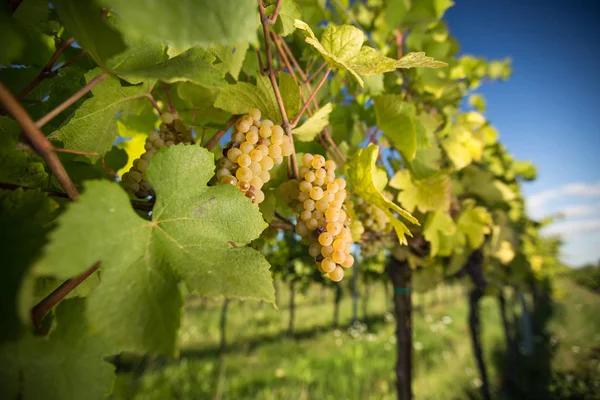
left=0, top=116, right=48, bottom=187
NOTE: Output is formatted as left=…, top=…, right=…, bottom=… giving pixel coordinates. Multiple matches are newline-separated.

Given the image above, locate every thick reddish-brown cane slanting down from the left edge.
left=0, top=82, right=79, bottom=200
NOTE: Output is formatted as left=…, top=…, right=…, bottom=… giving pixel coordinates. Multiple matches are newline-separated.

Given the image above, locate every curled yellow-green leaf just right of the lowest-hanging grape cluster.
left=346, top=144, right=419, bottom=244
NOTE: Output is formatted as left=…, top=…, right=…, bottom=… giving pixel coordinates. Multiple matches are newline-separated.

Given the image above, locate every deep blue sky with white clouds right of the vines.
left=445, top=0, right=600, bottom=265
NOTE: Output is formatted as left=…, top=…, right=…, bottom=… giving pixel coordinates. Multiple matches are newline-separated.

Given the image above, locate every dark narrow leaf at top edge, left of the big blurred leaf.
left=52, top=0, right=126, bottom=66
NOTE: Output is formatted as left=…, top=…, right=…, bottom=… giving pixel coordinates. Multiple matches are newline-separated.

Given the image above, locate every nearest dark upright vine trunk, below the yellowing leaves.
left=387, top=257, right=413, bottom=400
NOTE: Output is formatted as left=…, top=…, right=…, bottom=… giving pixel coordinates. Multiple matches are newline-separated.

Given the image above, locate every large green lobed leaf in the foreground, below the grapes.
left=36, top=145, right=274, bottom=354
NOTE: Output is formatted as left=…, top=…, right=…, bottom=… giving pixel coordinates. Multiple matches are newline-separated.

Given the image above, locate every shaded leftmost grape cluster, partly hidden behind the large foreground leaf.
left=121, top=113, right=192, bottom=199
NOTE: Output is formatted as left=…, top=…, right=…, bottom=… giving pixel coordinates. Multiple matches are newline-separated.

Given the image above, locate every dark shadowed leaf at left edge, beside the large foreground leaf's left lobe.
left=0, top=190, right=56, bottom=343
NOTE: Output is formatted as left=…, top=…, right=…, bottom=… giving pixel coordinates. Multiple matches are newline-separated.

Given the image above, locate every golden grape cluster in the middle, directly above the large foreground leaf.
left=216, top=109, right=294, bottom=204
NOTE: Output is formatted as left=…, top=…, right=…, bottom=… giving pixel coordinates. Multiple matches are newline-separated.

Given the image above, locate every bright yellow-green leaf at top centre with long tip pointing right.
left=294, top=20, right=448, bottom=87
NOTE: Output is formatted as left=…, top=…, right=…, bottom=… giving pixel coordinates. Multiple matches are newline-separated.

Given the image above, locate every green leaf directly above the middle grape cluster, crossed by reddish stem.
left=215, top=74, right=300, bottom=124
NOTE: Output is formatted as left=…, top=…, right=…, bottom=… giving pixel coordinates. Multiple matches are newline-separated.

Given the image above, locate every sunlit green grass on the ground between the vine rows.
left=113, top=281, right=600, bottom=400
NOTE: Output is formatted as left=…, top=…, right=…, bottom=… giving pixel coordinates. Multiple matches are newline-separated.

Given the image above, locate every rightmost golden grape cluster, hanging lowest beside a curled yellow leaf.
left=280, top=153, right=354, bottom=282
